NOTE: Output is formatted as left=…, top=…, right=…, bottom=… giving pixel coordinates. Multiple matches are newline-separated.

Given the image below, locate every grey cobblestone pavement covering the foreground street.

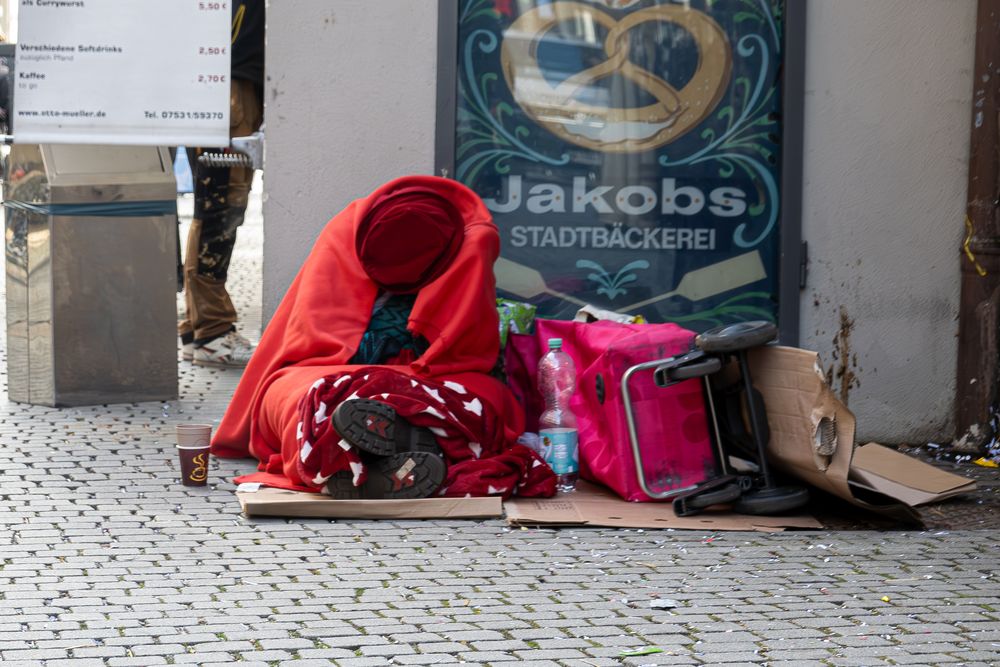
left=0, top=187, right=1000, bottom=667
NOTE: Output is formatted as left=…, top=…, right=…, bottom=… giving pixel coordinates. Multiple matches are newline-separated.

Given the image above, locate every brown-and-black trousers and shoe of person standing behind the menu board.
left=178, top=79, right=263, bottom=367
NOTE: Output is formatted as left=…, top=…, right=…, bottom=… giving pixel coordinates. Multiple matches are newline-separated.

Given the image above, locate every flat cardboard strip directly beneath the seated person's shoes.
left=236, top=487, right=503, bottom=519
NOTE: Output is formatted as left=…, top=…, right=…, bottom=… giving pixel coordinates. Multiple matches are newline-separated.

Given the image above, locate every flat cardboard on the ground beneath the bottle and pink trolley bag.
left=504, top=482, right=822, bottom=532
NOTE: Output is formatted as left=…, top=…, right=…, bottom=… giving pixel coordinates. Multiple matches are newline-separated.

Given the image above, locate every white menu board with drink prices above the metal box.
left=13, top=0, right=232, bottom=146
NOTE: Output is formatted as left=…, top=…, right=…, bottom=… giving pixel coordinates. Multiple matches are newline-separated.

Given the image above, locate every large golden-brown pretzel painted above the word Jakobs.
left=500, top=1, right=732, bottom=153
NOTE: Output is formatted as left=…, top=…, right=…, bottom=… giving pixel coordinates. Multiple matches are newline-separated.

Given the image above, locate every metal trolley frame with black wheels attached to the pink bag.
left=621, top=321, right=809, bottom=516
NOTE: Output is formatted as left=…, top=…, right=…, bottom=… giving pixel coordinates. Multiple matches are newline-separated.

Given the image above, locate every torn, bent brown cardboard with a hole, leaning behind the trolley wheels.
left=749, top=345, right=975, bottom=523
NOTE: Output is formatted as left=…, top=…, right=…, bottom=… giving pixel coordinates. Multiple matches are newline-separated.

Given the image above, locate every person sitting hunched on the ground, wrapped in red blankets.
left=212, top=176, right=555, bottom=498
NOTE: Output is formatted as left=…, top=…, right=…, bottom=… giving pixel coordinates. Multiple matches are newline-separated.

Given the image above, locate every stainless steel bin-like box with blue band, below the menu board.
left=4, top=144, right=177, bottom=406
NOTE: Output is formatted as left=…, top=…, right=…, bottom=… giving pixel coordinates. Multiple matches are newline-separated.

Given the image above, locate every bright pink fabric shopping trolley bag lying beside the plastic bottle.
left=505, top=320, right=719, bottom=502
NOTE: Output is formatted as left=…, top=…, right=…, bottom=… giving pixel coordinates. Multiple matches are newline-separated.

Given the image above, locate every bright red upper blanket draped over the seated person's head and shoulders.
left=212, top=176, right=500, bottom=458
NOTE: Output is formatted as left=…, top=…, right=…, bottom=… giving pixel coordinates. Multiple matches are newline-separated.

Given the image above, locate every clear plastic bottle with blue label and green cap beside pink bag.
left=538, top=338, right=580, bottom=492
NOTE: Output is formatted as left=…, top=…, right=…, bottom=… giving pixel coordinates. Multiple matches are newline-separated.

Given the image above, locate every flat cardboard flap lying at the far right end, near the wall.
left=851, top=442, right=976, bottom=507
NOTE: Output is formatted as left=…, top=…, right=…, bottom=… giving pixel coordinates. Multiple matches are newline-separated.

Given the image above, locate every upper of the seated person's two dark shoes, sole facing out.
left=333, top=398, right=441, bottom=456
